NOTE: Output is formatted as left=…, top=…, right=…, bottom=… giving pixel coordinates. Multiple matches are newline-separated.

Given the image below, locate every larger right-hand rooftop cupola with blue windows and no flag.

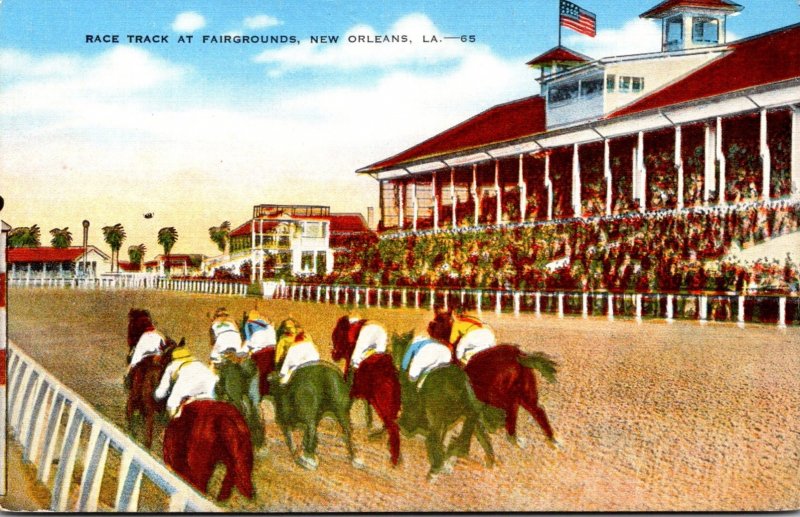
left=640, top=0, right=744, bottom=52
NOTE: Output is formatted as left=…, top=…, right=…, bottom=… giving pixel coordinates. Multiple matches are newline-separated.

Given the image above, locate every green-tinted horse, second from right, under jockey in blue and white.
left=392, top=332, right=495, bottom=481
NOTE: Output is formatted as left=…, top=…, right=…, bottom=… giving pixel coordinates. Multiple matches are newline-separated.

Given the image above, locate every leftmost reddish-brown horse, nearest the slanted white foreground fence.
left=125, top=309, right=177, bottom=449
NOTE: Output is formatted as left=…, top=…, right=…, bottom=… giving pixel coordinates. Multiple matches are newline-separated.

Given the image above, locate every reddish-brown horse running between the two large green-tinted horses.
left=331, top=316, right=400, bottom=466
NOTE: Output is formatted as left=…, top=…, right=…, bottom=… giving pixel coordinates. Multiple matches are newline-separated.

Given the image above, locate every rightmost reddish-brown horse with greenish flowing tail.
left=428, top=310, right=558, bottom=447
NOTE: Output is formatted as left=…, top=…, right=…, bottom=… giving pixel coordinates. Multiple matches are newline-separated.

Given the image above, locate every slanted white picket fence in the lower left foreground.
left=8, top=343, right=221, bottom=512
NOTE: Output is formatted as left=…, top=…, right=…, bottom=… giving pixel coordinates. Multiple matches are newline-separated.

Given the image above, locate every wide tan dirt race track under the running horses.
left=9, top=289, right=800, bottom=512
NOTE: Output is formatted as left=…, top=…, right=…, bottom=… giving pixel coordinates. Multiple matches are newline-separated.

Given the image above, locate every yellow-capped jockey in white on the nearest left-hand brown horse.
left=153, top=340, right=218, bottom=418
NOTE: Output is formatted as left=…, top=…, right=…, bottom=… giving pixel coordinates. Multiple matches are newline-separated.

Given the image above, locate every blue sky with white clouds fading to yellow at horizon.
left=0, top=0, right=800, bottom=260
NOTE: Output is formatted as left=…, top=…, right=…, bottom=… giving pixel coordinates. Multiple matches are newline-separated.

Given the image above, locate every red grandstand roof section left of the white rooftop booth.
left=359, top=95, right=546, bottom=172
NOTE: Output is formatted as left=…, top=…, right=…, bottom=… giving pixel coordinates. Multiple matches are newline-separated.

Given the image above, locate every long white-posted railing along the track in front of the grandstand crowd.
left=274, top=283, right=800, bottom=328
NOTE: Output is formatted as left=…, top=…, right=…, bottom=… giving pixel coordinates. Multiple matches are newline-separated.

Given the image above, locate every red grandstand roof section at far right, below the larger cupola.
left=606, top=24, right=800, bottom=118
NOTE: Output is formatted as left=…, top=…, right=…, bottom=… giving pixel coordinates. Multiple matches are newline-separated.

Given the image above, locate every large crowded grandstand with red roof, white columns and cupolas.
left=326, top=0, right=800, bottom=293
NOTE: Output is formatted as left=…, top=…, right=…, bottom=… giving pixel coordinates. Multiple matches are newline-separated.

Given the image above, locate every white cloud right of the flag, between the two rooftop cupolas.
left=565, top=18, right=661, bottom=59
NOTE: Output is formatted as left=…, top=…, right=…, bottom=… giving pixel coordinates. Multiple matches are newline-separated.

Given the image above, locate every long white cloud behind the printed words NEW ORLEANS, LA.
left=254, top=13, right=486, bottom=75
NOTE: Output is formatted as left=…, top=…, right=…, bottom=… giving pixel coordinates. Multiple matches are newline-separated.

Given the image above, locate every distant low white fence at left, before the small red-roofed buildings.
left=8, top=275, right=248, bottom=296
